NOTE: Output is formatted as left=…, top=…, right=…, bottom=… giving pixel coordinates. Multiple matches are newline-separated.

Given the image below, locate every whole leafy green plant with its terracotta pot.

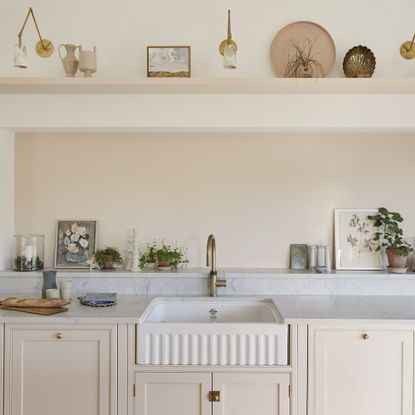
left=368, top=207, right=413, bottom=273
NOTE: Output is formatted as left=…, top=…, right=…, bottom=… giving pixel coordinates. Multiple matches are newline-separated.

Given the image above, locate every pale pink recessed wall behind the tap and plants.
left=15, top=133, right=415, bottom=268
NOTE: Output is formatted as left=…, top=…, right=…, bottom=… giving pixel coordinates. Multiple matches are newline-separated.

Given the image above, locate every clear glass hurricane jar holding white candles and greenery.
left=13, top=235, right=45, bottom=272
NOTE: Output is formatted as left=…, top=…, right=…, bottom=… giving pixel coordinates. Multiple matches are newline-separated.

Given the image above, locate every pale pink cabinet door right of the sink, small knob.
left=308, top=328, right=413, bottom=415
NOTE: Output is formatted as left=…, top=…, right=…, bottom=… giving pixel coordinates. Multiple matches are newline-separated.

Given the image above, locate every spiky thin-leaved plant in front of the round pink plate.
left=284, top=39, right=324, bottom=78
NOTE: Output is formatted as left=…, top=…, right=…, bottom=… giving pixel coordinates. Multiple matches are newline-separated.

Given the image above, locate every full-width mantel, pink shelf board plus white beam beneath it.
left=0, top=77, right=415, bottom=134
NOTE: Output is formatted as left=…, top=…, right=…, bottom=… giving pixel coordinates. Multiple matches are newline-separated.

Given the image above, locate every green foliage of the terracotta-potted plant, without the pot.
left=368, top=207, right=413, bottom=257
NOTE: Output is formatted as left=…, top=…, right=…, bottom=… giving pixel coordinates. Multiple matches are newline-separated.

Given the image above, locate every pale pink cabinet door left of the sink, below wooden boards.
left=5, top=324, right=117, bottom=415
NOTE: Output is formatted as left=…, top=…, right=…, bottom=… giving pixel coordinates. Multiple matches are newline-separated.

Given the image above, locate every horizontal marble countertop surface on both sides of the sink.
left=0, top=295, right=415, bottom=325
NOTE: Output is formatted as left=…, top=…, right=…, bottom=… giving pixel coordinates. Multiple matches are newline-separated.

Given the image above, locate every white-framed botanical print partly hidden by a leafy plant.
left=334, top=209, right=382, bottom=270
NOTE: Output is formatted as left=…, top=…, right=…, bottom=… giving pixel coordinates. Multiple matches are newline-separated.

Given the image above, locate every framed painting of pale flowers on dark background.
left=55, top=220, right=97, bottom=268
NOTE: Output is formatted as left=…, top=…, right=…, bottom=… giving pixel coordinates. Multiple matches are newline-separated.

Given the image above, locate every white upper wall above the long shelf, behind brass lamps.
left=0, top=0, right=415, bottom=77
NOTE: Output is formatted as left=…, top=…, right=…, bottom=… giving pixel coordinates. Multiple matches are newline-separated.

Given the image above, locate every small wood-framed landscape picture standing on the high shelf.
left=147, top=46, right=191, bottom=78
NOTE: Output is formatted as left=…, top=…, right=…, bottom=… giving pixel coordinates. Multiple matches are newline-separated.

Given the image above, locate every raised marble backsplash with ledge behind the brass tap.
left=0, top=269, right=415, bottom=298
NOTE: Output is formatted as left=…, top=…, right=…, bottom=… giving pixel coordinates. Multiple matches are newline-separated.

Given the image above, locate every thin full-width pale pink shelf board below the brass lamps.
left=0, top=77, right=415, bottom=94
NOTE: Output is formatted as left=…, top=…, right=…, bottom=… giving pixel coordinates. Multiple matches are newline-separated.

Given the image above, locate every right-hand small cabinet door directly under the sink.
left=212, top=373, right=290, bottom=415
